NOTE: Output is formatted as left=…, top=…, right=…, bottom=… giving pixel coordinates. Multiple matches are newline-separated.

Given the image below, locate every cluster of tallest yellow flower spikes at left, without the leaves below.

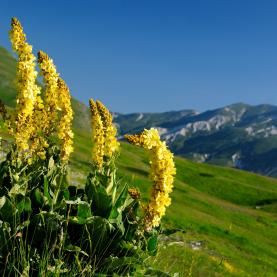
left=10, top=18, right=73, bottom=163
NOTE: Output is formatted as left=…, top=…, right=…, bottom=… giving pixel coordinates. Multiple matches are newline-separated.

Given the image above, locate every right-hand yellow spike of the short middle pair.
left=96, top=101, right=119, bottom=158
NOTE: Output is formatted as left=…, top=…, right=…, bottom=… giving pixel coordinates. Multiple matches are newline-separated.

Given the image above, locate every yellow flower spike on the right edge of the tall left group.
left=57, top=78, right=74, bottom=162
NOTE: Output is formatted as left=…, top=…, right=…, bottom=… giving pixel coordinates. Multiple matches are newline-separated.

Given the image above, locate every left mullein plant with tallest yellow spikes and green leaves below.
left=0, top=18, right=73, bottom=275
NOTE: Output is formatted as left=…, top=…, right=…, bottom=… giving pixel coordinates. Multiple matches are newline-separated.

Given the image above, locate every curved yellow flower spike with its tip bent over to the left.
left=125, top=128, right=176, bottom=230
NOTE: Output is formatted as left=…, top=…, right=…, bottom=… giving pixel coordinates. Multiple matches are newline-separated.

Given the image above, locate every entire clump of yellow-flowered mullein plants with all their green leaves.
left=0, top=18, right=175, bottom=276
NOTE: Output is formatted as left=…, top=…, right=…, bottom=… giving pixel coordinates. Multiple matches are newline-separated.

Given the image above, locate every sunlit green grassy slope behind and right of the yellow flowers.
left=72, top=128, right=277, bottom=276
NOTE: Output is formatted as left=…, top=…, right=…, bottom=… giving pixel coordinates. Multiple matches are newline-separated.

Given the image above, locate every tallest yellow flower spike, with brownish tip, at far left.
left=10, top=18, right=40, bottom=154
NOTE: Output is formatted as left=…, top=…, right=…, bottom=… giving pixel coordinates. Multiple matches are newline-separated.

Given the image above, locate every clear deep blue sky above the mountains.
left=0, top=0, right=277, bottom=113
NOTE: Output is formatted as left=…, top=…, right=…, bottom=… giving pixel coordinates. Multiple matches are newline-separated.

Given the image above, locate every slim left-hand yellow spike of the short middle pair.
left=89, top=99, right=105, bottom=170
